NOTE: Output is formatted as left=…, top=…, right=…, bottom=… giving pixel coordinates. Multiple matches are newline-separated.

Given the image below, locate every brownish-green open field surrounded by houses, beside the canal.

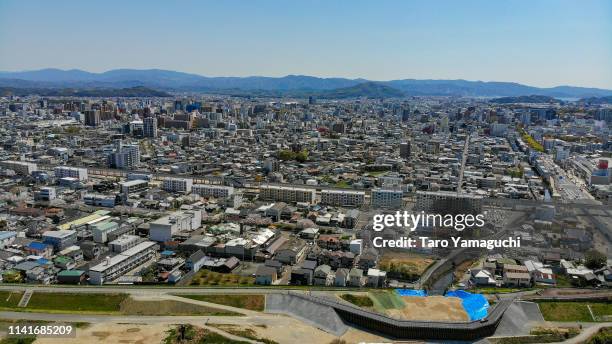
left=380, top=252, right=435, bottom=281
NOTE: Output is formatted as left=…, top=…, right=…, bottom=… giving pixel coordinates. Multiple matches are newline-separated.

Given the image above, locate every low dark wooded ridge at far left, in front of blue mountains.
left=0, top=86, right=171, bottom=97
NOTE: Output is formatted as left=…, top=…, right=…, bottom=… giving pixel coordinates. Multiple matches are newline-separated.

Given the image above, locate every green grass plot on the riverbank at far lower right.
left=538, top=301, right=612, bottom=322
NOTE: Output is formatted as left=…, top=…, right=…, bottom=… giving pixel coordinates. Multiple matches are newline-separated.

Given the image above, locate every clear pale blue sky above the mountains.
left=0, top=0, right=612, bottom=89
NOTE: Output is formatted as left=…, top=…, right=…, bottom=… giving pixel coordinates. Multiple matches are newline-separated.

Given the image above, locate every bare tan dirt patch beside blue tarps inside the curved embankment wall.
left=386, top=296, right=469, bottom=321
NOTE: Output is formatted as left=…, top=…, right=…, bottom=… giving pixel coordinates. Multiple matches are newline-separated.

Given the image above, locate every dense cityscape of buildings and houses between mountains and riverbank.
left=0, top=88, right=612, bottom=342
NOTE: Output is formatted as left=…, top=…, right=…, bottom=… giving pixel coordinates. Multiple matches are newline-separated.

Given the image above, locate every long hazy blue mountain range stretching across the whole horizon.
left=0, top=69, right=612, bottom=99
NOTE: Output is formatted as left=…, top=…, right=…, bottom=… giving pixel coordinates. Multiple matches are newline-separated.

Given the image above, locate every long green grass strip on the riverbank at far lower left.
left=11, top=293, right=127, bottom=314
